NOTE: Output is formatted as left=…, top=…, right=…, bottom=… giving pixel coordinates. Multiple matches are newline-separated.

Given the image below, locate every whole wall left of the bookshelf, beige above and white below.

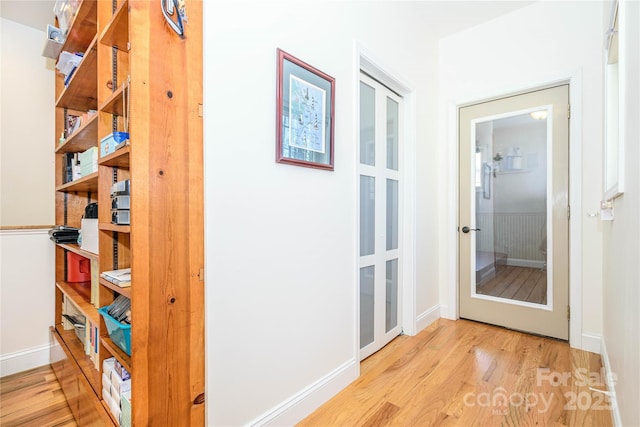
left=0, top=18, right=55, bottom=376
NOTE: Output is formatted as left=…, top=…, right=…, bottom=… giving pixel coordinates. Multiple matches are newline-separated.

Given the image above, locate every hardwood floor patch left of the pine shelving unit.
left=0, top=365, right=77, bottom=427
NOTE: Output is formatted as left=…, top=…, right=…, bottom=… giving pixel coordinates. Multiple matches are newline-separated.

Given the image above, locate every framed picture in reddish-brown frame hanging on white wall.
left=276, top=49, right=335, bottom=170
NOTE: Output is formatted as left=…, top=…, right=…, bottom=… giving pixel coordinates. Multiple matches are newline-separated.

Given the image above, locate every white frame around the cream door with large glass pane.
left=442, top=69, right=588, bottom=354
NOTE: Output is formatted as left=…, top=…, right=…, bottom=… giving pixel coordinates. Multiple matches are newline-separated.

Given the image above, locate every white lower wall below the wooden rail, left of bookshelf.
left=0, top=229, right=55, bottom=377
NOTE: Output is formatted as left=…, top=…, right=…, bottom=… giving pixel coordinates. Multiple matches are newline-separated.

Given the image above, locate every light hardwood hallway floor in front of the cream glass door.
left=299, top=319, right=612, bottom=427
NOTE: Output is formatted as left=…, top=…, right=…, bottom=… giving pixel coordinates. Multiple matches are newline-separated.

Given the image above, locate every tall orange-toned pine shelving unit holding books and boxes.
left=51, top=0, right=204, bottom=426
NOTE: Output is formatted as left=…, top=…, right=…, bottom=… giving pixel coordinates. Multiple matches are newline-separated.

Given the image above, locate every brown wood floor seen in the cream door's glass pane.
left=477, top=266, right=547, bottom=304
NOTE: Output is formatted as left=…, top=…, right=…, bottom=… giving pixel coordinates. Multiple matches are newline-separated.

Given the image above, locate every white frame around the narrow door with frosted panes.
left=352, top=41, right=418, bottom=368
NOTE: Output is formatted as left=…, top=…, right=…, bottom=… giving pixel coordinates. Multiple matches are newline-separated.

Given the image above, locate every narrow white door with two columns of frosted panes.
left=359, top=74, right=402, bottom=359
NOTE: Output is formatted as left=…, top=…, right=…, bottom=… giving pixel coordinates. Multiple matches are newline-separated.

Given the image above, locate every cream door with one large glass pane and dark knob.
left=459, top=85, right=570, bottom=340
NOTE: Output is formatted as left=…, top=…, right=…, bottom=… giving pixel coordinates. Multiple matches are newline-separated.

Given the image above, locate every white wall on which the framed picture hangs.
left=205, top=1, right=438, bottom=425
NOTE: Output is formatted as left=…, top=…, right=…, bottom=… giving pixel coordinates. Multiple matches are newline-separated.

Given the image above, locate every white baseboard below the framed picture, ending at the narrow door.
left=248, top=359, right=359, bottom=426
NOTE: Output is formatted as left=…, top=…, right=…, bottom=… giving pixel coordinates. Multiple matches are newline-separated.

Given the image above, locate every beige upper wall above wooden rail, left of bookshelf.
left=0, top=18, right=55, bottom=227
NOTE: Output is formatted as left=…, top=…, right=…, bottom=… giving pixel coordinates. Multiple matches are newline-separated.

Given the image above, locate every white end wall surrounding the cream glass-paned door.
left=439, top=1, right=603, bottom=344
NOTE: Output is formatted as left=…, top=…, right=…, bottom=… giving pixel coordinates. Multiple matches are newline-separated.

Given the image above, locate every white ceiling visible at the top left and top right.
left=0, top=0, right=533, bottom=33
